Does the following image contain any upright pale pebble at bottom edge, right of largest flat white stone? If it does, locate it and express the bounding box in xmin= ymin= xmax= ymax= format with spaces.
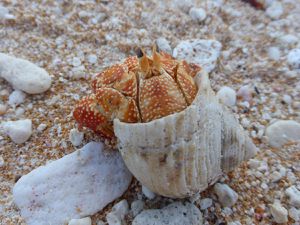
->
xmin=106 ymin=199 xmax=129 ymax=225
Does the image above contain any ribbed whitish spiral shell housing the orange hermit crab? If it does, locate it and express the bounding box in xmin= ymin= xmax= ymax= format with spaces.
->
xmin=114 ymin=71 xmax=256 ymax=198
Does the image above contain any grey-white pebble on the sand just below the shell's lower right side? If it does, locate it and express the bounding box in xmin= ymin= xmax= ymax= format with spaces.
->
xmin=214 ymin=183 xmax=238 ymax=207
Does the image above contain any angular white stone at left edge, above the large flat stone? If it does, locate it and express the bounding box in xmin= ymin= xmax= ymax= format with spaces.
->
xmin=1 ymin=119 xmax=32 ymax=144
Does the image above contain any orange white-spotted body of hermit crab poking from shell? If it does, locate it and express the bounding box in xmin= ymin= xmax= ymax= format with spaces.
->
xmin=73 ymin=47 xmax=201 ymax=139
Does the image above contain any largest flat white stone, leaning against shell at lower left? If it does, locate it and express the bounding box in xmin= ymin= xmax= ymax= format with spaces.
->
xmin=13 ymin=142 xmax=132 ymax=225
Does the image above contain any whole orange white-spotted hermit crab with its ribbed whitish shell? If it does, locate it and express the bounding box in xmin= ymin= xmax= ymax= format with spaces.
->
xmin=74 ymin=47 xmax=256 ymax=198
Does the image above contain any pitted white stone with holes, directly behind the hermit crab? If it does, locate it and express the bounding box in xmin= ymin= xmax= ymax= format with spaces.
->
xmin=173 ymin=39 xmax=222 ymax=73
